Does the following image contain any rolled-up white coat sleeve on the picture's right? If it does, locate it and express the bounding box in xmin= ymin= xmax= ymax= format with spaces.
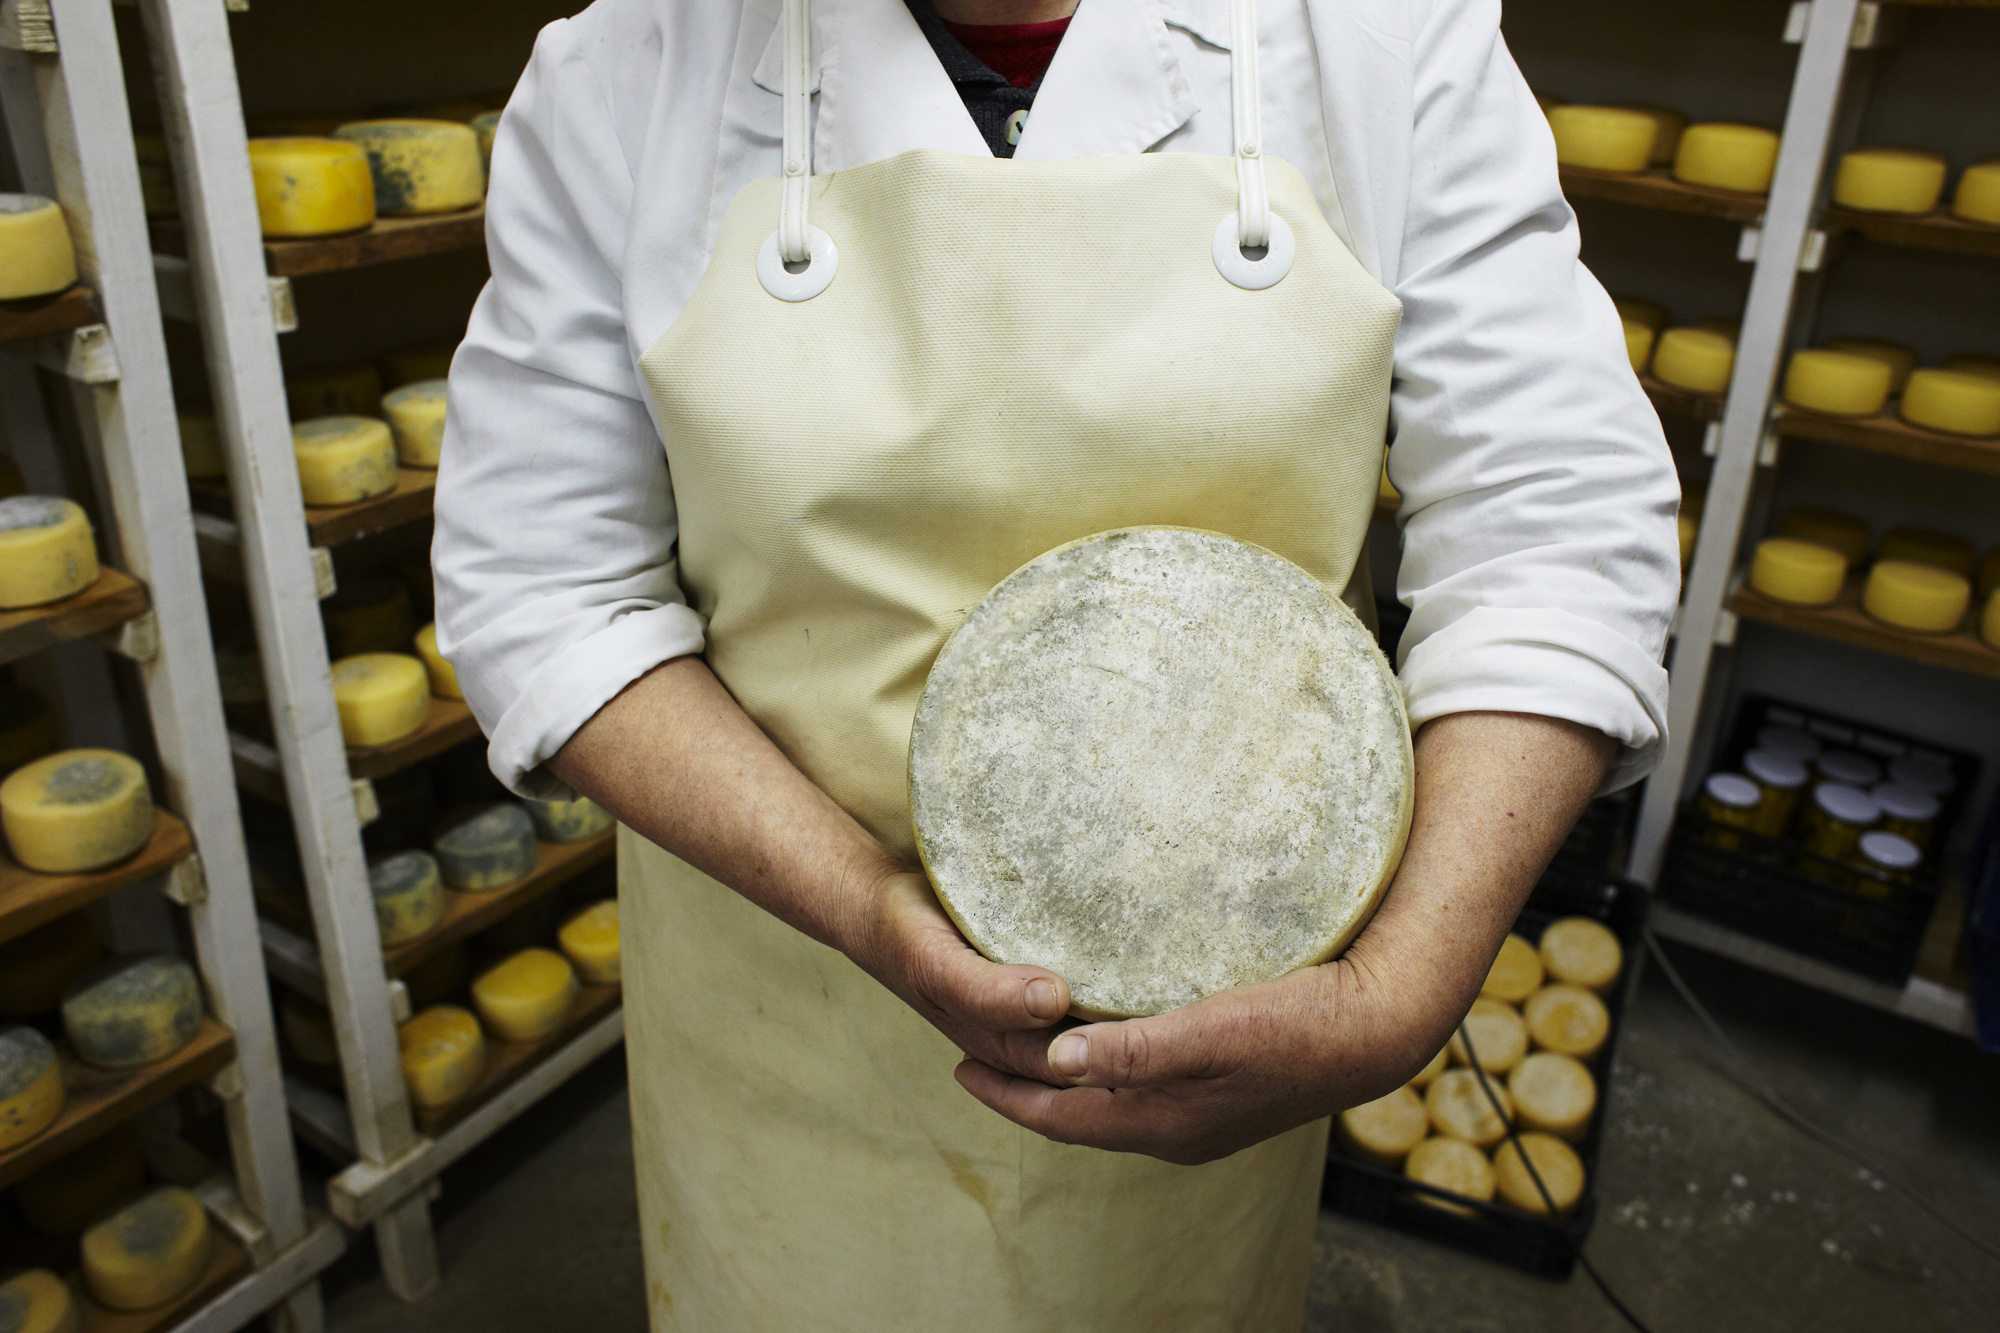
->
xmin=1388 ymin=0 xmax=1680 ymax=791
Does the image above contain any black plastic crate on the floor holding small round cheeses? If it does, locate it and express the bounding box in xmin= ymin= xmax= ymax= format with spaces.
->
xmin=1320 ymin=879 xmax=1646 ymax=1281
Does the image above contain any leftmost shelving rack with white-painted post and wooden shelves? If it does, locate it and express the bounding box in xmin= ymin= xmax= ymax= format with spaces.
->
xmin=0 ymin=0 xmax=346 ymax=1333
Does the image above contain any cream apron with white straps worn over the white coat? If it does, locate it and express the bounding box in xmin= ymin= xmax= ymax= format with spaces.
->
xmin=618 ymin=0 xmax=1398 ymax=1333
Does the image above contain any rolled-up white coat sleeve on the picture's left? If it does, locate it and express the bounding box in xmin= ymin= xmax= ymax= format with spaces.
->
xmin=432 ymin=22 xmax=702 ymax=799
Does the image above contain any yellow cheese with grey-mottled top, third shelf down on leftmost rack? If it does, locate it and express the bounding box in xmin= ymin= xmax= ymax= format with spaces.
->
xmin=0 ymin=751 xmax=152 ymax=875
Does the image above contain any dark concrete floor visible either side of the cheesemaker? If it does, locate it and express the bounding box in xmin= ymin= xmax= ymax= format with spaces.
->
xmin=312 ymin=951 xmax=2000 ymax=1333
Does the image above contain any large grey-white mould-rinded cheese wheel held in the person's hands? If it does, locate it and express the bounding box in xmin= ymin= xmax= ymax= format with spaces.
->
xmin=910 ymin=528 xmax=1412 ymax=1019
